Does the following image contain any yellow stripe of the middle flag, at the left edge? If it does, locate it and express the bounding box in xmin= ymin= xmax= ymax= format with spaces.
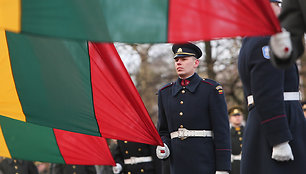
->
xmin=0 ymin=29 xmax=26 ymax=121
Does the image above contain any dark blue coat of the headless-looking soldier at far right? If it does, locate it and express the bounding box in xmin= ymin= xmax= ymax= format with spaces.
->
xmin=238 ymin=37 xmax=306 ymax=174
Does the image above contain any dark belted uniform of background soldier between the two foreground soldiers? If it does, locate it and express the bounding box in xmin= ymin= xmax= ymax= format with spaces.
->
xmin=230 ymin=126 xmax=244 ymax=174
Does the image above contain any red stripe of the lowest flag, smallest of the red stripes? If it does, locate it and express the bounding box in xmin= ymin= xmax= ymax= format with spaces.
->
xmin=53 ymin=129 xmax=115 ymax=165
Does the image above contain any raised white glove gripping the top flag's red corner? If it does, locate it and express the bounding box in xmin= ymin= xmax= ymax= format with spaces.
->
xmin=270 ymin=28 xmax=292 ymax=59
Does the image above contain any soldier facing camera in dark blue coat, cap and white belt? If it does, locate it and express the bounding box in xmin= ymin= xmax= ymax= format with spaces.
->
xmin=156 ymin=43 xmax=231 ymax=174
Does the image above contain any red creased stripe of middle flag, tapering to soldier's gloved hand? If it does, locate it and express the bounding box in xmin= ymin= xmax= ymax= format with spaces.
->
xmin=88 ymin=42 xmax=163 ymax=145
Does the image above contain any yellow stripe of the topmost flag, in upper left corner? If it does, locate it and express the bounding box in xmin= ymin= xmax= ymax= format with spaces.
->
xmin=0 ymin=0 xmax=21 ymax=32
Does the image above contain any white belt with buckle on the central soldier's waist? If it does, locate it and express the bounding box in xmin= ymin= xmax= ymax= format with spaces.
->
xmin=170 ymin=128 xmax=213 ymax=139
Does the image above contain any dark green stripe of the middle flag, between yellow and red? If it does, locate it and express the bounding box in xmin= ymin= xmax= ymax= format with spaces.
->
xmin=7 ymin=32 xmax=100 ymax=136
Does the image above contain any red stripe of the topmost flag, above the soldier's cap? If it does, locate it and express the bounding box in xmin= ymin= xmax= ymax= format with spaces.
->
xmin=168 ymin=0 xmax=280 ymax=42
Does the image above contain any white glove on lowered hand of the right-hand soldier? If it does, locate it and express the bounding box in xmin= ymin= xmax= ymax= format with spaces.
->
xmin=272 ymin=141 xmax=294 ymax=161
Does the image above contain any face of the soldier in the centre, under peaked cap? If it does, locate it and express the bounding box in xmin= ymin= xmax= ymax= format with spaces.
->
xmin=175 ymin=56 xmax=199 ymax=79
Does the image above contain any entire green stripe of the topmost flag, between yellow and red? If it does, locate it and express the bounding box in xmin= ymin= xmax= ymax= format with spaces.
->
xmin=21 ymin=0 xmax=168 ymax=42
